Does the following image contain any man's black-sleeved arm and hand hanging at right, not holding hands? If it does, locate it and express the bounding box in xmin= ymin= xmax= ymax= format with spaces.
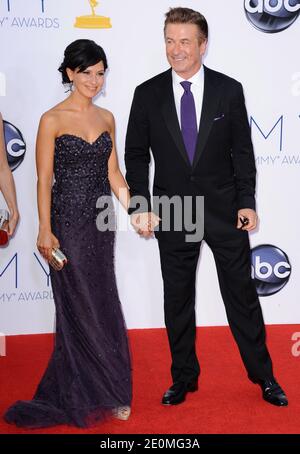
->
xmin=231 ymin=84 xmax=257 ymax=231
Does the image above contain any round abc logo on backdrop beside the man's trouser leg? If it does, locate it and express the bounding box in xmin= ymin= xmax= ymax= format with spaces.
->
xmin=251 ymin=244 xmax=291 ymax=296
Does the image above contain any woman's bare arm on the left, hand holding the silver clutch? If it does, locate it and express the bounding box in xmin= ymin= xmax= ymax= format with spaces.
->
xmin=36 ymin=113 xmax=59 ymax=261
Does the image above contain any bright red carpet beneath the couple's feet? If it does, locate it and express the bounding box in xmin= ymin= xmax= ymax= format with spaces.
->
xmin=0 ymin=325 xmax=300 ymax=434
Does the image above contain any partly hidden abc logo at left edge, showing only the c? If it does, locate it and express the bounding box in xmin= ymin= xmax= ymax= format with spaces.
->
xmin=3 ymin=121 xmax=26 ymax=171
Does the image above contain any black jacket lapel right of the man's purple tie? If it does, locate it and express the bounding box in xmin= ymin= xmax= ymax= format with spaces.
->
xmin=193 ymin=66 xmax=221 ymax=167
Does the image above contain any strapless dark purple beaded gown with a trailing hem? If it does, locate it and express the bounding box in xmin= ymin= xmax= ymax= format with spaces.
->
xmin=5 ymin=132 xmax=132 ymax=428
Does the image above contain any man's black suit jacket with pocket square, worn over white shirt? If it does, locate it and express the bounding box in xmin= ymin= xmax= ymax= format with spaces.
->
xmin=125 ymin=66 xmax=256 ymax=241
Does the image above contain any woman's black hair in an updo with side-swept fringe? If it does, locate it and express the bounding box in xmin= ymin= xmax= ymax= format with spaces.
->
xmin=58 ymin=39 xmax=107 ymax=84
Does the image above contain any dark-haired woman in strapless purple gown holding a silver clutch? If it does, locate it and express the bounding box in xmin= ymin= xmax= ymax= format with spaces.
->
xmin=5 ymin=39 xmax=132 ymax=428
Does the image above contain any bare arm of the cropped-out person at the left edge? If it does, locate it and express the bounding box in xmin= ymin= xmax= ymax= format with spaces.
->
xmin=0 ymin=114 xmax=19 ymax=236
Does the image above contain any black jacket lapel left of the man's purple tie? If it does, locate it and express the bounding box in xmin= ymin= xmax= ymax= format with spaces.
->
xmin=159 ymin=69 xmax=191 ymax=167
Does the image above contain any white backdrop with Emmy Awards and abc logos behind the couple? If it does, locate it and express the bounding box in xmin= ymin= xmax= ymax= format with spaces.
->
xmin=0 ymin=0 xmax=300 ymax=334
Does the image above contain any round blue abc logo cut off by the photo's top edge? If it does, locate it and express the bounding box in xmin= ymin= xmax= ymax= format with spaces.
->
xmin=244 ymin=0 xmax=300 ymax=33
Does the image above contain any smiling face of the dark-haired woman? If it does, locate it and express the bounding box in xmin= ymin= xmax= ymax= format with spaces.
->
xmin=67 ymin=61 xmax=105 ymax=98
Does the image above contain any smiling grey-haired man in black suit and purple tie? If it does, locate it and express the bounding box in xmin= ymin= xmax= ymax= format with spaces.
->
xmin=125 ymin=8 xmax=288 ymax=406
